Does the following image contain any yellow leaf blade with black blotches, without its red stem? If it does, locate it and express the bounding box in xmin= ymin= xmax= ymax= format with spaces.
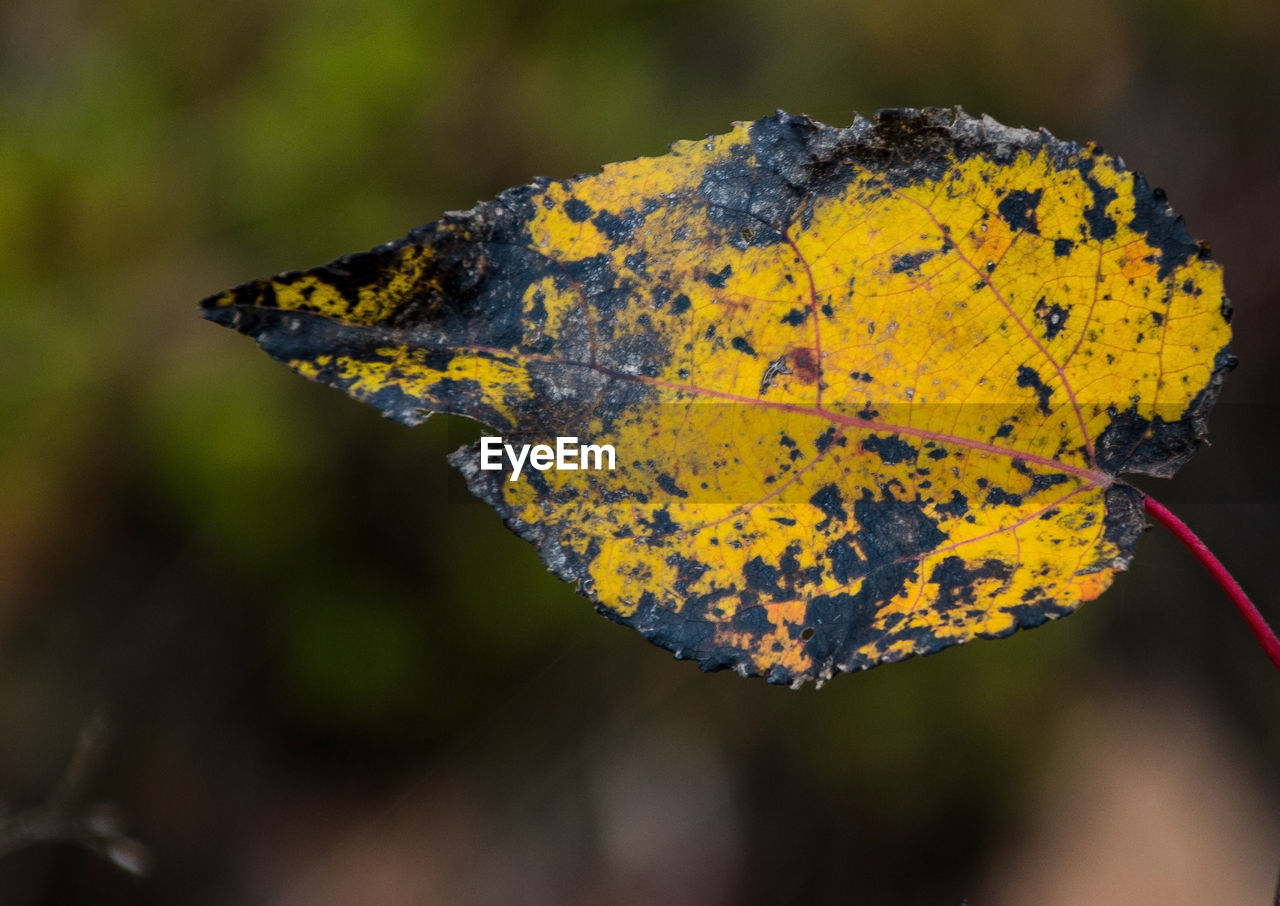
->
xmin=204 ymin=109 xmax=1234 ymax=685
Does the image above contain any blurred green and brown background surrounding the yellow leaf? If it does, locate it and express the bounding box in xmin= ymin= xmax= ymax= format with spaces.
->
xmin=0 ymin=0 xmax=1280 ymax=906
